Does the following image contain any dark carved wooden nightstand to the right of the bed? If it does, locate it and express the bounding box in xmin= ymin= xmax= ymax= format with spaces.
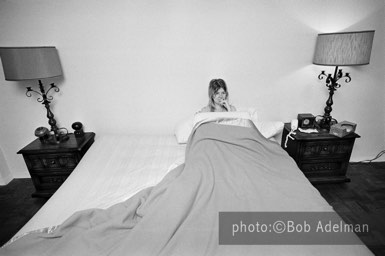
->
xmin=281 ymin=123 xmax=360 ymax=183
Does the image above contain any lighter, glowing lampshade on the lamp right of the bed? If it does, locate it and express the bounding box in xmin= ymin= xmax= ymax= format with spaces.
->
xmin=313 ymin=30 xmax=374 ymax=66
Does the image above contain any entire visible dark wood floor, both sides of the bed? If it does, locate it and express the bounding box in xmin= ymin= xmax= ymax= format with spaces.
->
xmin=0 ymin=162 xmax=385 ymax=255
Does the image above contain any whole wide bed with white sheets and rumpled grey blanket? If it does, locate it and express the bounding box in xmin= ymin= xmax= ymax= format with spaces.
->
xmin=0 ymin=112 xmax=372 ymax=255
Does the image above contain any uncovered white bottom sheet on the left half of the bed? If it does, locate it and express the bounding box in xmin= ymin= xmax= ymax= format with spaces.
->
xmin=15 ymin=135 xmax=186 ymax=236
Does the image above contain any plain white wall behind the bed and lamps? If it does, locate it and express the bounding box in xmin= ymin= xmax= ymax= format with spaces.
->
xmin=0 ymin=0 xmax=385 ymax=180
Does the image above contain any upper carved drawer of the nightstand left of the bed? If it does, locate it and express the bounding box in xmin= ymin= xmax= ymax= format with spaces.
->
xmin=24 ymin=153 xmax=79 ymax=170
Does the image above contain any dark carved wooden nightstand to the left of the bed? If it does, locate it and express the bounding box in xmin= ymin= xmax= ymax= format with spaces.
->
xmin=17 ymin=132 xmax=95 ymax=197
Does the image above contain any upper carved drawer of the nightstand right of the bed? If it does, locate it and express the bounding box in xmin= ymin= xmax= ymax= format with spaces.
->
xmin=300 ymin=140 xmax=354 ymax=159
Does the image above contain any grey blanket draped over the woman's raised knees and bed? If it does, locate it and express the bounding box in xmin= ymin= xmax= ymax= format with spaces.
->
xmin=0 ymin=123 xmax=370 ymax=256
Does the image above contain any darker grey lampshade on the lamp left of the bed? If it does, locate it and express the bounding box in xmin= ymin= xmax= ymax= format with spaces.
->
xmin=0 ymin=46 xmax=62 ymax=81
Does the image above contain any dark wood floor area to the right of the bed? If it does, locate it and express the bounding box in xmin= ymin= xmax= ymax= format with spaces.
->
xmin=315 ymin=162 xmax=385 ymax=255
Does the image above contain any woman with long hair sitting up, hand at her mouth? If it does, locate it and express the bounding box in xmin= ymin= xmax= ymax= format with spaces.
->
xmin=199 ymin=79 xmax=236 ymax=112
